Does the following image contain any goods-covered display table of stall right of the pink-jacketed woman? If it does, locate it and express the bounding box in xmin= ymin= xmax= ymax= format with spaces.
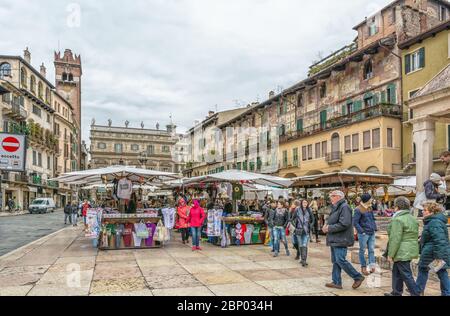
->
xmin=214 ymin=216 xmax=267 ymax=247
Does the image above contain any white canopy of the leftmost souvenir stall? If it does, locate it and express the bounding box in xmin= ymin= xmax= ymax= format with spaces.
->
xmin=53 ymin=166 xmax=179 ymax=185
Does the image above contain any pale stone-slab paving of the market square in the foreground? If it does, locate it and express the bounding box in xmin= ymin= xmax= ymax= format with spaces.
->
xmin=0 ymin=227 xmax=440 ymax=296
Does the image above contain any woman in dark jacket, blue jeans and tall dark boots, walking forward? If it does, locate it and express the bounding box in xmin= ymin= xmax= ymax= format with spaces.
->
xmin=291 ymin=200 xmax=314 ymax=267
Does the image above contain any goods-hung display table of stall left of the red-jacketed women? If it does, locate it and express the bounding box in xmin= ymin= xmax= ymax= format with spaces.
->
xmin=98 ymin=214 xmax=164 ymax=250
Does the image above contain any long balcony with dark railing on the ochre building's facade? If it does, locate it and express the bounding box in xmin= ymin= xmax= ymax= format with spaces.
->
xmin=280 ymin=104 xmax=402 ymax=143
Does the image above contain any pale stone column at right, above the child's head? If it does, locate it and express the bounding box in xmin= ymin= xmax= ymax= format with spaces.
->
xmin=413 ymin=118 xmax=436 ymax=192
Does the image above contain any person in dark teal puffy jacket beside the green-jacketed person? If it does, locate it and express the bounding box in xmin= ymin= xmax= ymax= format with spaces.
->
xmin=416 ymin=202 xmax=450 ymax=296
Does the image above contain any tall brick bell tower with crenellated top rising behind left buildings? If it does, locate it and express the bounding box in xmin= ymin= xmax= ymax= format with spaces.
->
xmin=54 ymin=49 xmax=83 ymax=130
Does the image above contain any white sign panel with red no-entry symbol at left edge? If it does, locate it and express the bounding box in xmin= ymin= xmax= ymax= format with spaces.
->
xmin=0 ymin=133 xmax=27 ymax=171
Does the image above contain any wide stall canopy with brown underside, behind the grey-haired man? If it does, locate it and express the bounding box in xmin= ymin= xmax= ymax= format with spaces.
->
xmin=291 ymin=171 xmax=394 ymax=188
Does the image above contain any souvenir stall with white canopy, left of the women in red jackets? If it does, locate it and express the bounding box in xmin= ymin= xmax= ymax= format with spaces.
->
xmin=55 ymin=166 xmax=177 ymax=250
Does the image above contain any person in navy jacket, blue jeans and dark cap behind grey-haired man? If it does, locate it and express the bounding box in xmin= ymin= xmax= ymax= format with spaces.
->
xmin=353 ymin=193 xmax=377 ymax=276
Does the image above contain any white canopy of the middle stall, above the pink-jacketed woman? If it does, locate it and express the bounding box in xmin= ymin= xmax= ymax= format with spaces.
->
xmin=183 ymin=170 xmax=292 ymax=187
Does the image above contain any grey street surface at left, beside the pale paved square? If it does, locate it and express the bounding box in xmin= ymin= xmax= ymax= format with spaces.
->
xmin=0 ymin=209 xmax=64 ymax=256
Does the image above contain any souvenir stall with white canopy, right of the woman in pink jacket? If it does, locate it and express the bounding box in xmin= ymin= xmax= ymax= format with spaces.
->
xmin=183 ymin=170 xmax=292 ymax=247
